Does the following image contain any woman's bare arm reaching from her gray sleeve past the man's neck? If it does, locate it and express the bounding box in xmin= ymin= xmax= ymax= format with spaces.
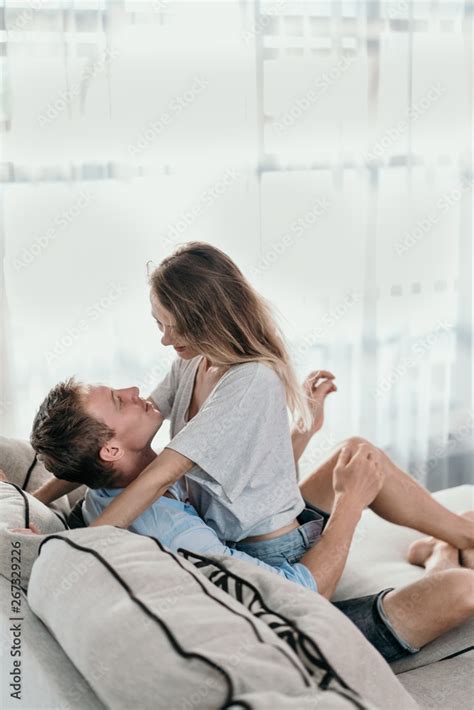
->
xmin=90 ymin=449 xmax=194 ymax=528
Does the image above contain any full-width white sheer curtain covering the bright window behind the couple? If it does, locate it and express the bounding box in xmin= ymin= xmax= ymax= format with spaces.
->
xmin=0 ymin=0 xmax=473 ymax=488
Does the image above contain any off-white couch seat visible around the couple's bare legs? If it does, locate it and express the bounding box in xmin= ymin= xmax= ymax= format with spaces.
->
xmin=333 ymin=485 xmax=474 ymax=673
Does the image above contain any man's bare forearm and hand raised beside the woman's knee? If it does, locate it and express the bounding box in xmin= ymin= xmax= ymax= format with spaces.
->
xmin=300 ymin=444 xmax=384 ymax=599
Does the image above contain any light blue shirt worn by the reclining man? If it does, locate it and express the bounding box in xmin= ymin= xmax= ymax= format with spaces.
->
xmin=82 ymin=488 xmax=317 ymax=591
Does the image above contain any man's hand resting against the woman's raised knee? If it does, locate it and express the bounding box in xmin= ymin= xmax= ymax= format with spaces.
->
xmin=333 ymin=444 xmax=385 ymax=510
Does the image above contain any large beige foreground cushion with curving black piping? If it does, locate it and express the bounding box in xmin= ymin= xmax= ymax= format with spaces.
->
xmin=28 ymin=526 xmax=416 ymax=710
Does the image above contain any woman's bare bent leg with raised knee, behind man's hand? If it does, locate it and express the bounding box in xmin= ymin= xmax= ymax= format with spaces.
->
xmin=301 ymin=437 xmax=474 ymax=550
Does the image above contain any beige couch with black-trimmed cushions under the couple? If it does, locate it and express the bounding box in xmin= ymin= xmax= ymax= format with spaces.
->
xmin=0 ymin=437 xmax=474 ymax=710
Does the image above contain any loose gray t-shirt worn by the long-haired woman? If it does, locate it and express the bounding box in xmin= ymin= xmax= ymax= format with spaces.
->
xmin=151 ymin=356 xmax=304 ymax=542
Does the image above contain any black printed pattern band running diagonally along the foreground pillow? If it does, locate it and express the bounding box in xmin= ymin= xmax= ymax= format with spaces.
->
xmin=178 ymin=549 xmax=364 ymax=708
